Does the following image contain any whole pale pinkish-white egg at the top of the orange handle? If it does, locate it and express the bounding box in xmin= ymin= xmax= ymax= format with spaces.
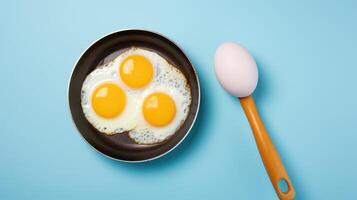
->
xmin=214 ymin=42 xmax=258 ymax=97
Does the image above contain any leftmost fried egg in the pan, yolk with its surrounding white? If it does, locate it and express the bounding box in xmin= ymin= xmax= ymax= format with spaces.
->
xmin=81 ymin=62 xmax=139 ymax=135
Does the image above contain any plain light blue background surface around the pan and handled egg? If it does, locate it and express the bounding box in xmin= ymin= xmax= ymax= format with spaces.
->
xmin=0 ymin=0 xmax=357 ymax=200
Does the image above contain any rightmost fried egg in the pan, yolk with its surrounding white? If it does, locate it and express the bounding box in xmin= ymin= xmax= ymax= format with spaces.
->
xmin=129 ymin=50 xmax=191 ymax=144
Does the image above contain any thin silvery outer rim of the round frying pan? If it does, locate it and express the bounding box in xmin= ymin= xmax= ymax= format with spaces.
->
xmin=67 ymin=28 xmax=201 ymax=163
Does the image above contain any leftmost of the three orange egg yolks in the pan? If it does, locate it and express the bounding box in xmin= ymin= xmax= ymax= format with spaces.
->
xmin=92 ymin=83 xmax=126 ymax=118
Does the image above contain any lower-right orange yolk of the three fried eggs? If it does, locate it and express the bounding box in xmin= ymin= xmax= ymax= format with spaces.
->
xmin=142 ymin=92 xmax=176 ymax=127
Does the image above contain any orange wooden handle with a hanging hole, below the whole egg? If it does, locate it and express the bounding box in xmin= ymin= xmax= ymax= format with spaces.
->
xmin=239 ymin=96 xmax=295 ymax=200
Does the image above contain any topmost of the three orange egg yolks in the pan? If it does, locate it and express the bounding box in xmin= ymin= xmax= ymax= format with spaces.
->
xmin=119 ymin=55 xmax=154 ymax=89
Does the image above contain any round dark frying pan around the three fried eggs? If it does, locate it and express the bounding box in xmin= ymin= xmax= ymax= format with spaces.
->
xmin=68 ymin=30 xmax=200 ymax=162
